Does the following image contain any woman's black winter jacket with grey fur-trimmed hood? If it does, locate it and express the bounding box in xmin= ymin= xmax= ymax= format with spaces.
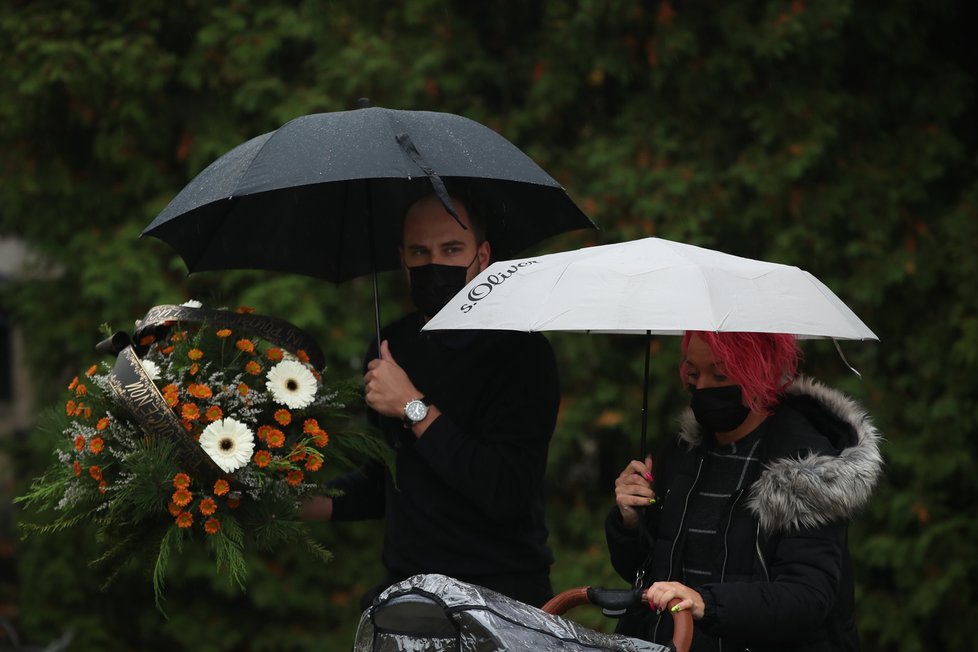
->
xmin=606 ymin=379 xmax=882 ymax=652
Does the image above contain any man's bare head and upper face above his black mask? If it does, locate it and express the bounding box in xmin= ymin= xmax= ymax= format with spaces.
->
xmin=401 ymin=195 xmax=489 ymax=282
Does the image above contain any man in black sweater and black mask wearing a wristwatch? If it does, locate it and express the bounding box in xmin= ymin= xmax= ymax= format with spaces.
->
xmin=307 ymin=195 xmax=560 ymax=607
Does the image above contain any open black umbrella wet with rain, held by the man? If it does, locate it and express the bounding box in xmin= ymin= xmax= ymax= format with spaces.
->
xmin=143 ymin=102 xmax=594 ymax=344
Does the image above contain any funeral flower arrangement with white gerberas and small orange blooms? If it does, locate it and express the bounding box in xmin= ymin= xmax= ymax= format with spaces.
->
xmin=17 ymin=304 xmax=390 ymax=603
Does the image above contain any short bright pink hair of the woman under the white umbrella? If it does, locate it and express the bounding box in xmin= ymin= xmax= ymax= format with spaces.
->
xmin=679 ymin=331 xmax=801 ymax=414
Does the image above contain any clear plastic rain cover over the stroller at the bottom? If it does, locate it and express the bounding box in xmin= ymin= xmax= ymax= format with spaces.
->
xmin=353 ymin=575 xmax=669 ymax=652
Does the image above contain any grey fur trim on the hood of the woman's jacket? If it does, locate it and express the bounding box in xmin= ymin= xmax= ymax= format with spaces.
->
xmin=679 ymin=377 xmax=883 ymax=533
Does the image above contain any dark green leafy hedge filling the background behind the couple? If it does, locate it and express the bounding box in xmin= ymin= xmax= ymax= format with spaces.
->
xmin=0 ymin=0 xmax=978 ymax=652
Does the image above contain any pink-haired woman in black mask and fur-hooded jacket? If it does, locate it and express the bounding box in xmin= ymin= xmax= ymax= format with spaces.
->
xmin=606 ymin=332 xmax=882 ymax=652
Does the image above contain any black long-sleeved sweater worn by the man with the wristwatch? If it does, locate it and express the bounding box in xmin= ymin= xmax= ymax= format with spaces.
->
xmin=333 ymin=314 xmax=560 ymax=601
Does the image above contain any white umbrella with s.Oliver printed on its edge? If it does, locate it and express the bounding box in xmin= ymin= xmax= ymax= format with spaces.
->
xmin=424 ymin=238 xmax=879 ymax=452
